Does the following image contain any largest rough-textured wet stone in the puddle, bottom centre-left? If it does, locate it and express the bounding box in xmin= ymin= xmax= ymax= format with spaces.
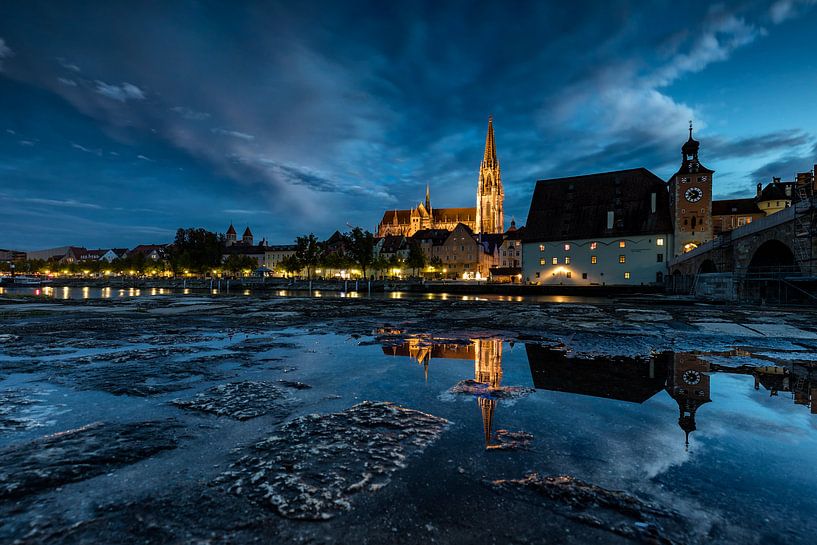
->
xmin=219 ymin=401 xmax=448 ymax=520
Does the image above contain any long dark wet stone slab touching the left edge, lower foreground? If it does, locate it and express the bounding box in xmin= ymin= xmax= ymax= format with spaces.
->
xmin=0 ymin=420 xmax=180 ymax=499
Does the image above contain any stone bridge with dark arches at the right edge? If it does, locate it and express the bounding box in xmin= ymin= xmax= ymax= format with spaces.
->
xmin=668 ymin=196 xmax=817 ymax=299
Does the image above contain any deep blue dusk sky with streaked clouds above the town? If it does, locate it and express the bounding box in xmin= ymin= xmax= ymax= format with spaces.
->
xmin=0 ymin=0 xmax=817 ymax=250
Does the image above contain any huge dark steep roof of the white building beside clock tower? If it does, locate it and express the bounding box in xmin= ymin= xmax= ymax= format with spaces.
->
xmin=523 ymin=168 xmax=672 ymax=242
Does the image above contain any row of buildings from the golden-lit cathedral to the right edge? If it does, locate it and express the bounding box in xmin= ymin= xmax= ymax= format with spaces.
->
xmin=377 ymin=119 xmax=817 ymax=285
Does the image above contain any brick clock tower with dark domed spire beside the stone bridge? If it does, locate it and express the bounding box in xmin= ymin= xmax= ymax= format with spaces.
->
xmin=669 ymin=121 xmax=715 ymax=255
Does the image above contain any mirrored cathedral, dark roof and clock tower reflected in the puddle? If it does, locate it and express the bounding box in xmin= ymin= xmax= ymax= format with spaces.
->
xmin=376 ymin=329 xmax=817 ymax=449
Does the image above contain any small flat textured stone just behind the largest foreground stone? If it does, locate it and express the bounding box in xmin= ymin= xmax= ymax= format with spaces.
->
xmin=171 ymin=380 xmax=289 ymax=420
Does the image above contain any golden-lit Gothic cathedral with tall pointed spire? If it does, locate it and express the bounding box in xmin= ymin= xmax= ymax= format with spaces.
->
xmin=377 ymin=117 xmax=505 ymax=237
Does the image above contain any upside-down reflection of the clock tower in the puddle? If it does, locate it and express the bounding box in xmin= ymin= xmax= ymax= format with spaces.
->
xmin=667 ymin=354 xmax=712 ymax=446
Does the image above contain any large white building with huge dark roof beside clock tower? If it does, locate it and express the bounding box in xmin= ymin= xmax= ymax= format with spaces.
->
xmin=522 ymin=168 xmax=673 ymax=286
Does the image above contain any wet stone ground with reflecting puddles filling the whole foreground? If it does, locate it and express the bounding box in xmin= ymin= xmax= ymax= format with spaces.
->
xmin=0 ymin=295 xmax=817 ymax=544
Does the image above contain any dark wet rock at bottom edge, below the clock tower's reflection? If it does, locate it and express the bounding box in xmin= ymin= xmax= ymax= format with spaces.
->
xmin=492 ymin=473 xmax=689 ymax=544
